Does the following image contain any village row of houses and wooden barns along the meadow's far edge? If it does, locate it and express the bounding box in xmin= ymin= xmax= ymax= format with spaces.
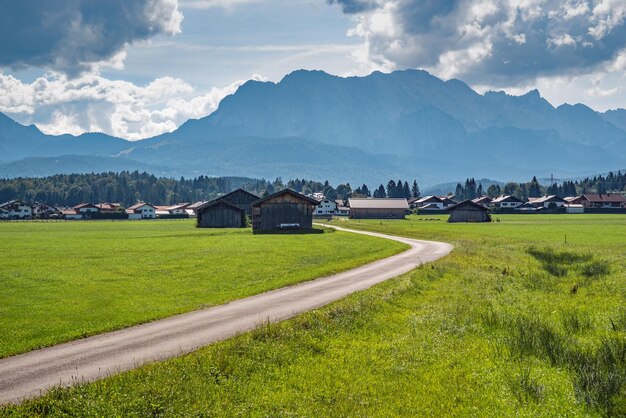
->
xmin=0 ymin=188 xmax=626 ymax=232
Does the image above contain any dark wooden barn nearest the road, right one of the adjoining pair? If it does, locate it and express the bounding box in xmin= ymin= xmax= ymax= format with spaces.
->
xmin=252 ymin=189 xmax=319 ymax=234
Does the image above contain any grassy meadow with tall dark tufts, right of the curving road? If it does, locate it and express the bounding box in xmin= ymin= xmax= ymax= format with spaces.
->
xmin=0 ymin=215 xmax=626 ymax=417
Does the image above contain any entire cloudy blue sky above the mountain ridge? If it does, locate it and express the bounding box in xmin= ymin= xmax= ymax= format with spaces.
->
xmin=0 ymin=0 xmax=626 ymax=140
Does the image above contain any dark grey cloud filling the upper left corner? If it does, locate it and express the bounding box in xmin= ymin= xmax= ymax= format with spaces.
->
xmin=0 ymin=0 xmax=183 ymax=75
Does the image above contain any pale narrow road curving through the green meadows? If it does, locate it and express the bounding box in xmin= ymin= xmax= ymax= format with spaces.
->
xmin=0 ymin=226 xmax=452 ymax=404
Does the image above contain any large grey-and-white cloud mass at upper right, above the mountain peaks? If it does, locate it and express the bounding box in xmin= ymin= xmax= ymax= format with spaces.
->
xmin=327 ymin=0 xmax=626 ymax=85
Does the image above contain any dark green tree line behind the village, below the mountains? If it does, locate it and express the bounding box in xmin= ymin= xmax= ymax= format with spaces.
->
xmin=0 ymin=171 xmax=626 ymax=206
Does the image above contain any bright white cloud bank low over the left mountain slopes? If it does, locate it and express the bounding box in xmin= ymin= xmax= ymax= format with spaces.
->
xmin=0 ymin=73 xmax=262 ymax=140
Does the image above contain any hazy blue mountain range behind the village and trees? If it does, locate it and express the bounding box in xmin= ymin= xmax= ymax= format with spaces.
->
xmin=0 ymin=70 xmax=626 ymax=185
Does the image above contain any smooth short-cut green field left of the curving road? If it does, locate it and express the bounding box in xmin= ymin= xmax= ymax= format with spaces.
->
xmin=0 ymin=221 xmax=405 ymax=357
